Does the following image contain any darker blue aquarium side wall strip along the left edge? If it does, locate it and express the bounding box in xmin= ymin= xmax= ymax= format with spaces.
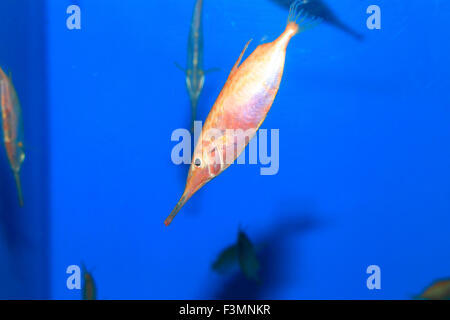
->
xmin=0 ymin=0 xmax=50 ymax=299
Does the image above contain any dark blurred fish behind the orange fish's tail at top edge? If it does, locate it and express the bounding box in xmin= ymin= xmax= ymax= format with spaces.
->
xmin=272 ymin=0 xmax=364 ymax=41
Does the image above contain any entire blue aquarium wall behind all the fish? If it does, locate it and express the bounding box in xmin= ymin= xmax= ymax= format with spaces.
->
xmin=0 ymin=0 xmax=450 ymax=299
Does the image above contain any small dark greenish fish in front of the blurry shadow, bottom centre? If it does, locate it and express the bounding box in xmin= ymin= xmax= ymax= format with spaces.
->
xmin=212 ymin=230 xmax=260 ymax=283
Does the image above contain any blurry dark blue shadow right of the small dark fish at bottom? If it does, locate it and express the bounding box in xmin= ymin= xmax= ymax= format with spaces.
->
xmin=212 ymin=206 xmax=321 ymax=300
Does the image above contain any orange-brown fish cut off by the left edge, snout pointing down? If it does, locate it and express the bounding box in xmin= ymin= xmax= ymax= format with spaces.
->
xmin=0 ymin=68 xmax=25 ymax=206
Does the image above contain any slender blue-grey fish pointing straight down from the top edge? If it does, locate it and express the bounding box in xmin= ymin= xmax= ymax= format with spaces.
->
xmin=176 ymin=0 xmax=216 ymax=132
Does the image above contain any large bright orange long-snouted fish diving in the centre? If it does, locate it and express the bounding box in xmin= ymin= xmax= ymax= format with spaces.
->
xmin=164 ymin=0 xmax=318 ymax=226
